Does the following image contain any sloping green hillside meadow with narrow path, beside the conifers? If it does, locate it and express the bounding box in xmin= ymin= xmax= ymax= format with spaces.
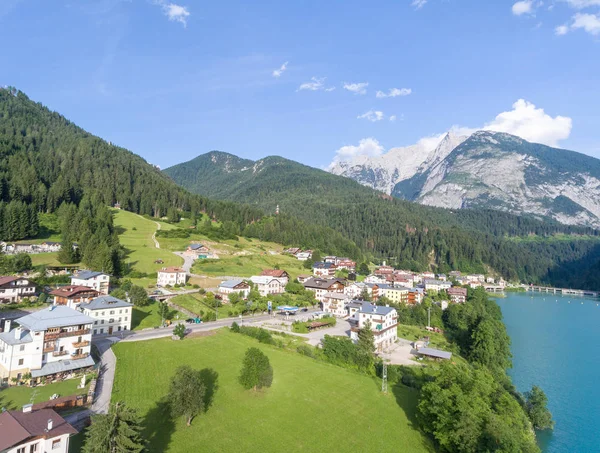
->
xmin=114 ymin=210 xmax=183 ymax=276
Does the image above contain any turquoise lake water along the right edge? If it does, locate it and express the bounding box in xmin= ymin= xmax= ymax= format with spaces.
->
xmin=497 ymin=293 xmax=600 ymax=453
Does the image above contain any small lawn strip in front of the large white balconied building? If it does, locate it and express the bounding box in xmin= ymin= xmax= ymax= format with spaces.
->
xmin=0 ymin=378 xmax=87 ymax=410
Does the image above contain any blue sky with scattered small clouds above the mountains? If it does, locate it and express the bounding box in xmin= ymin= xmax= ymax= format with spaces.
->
xmin=0 ymin=0 xmax=600 ymax=168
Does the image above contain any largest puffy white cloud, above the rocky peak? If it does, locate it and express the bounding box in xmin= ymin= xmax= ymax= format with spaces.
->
xmin=483 ymin=99 xmax=573 ymax=146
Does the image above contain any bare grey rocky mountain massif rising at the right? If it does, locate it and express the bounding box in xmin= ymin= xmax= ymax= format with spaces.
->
xmin=336 ymin=131 xmax=600 ymax=228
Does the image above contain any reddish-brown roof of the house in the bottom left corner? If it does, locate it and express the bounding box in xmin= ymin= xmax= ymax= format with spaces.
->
xmin=0 ymin=409 xmax=77 ymax=451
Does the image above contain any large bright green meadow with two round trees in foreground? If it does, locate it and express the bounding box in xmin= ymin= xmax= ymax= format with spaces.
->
xmin=112 ymin=331 xmax=434 ymax=453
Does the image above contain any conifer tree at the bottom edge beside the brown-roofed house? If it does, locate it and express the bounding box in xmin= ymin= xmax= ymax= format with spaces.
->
xmin=82 ymin=402 xmax=144 ymax=453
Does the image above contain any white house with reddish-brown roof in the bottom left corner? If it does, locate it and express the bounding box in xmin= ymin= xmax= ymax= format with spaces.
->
xmin=0 ymin=404 xmax=77 ymax=453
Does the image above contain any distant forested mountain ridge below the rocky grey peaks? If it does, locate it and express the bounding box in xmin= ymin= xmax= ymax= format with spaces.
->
xmin=165 ymin=152 xmax=598 ymax=288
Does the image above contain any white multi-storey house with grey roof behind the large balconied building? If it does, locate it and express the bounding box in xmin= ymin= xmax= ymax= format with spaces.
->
xmin=79 ymin=296 xmax=133 ymax=335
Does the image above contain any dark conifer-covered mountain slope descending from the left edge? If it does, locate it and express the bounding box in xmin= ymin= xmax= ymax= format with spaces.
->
xmin=0 ymin=88 xmax=361 ymax=266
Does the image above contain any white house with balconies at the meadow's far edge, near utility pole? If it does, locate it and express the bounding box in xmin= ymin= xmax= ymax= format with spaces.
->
xmin=350 ymin=302 xmax=398 ymax=352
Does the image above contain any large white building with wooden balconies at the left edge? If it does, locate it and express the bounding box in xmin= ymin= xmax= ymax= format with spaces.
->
xmin=0 ymin=305 xmax=94 ymax=384
